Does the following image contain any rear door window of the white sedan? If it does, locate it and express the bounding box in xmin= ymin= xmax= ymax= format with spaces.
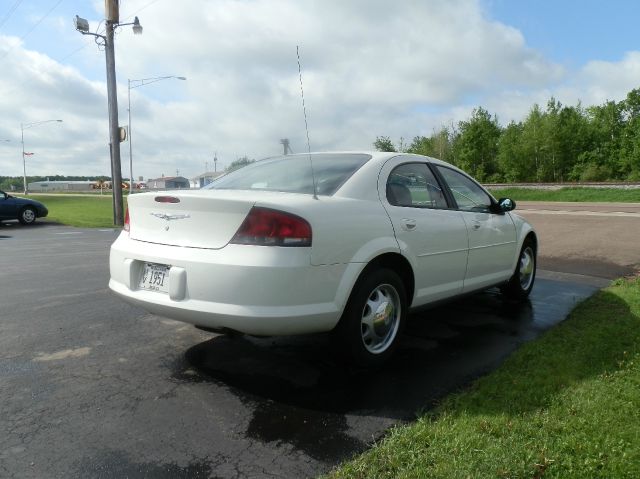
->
xmin=387 ymin=163 xmax=447 ymax=208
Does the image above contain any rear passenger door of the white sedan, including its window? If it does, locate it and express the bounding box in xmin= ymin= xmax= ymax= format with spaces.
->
xmin=379 ymin=155 xmax=468 ymax=306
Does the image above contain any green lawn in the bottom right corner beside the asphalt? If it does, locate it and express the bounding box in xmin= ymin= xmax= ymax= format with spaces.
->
xmin=329 ymin=278 xmax=640 ymax=479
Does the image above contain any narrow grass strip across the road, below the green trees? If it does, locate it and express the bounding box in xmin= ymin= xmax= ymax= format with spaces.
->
xmin=491 ymin=187 xmax=640 ymax=203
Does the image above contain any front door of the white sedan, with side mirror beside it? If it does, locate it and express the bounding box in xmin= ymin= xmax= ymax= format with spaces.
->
xmin=436 ymin=165 xmax=517 ymax=292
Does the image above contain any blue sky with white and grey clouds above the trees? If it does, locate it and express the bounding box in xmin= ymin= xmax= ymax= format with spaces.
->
xmin=0 ymin=0 xmax=640 ymax=178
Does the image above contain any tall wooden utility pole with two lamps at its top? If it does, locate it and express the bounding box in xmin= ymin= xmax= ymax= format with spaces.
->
xmin=74 ymin=0 xmax=142 ymax=226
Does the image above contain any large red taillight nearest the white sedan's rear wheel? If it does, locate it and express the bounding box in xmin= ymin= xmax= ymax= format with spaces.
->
xmin=231 ymin=206 xmax=311 ymax=246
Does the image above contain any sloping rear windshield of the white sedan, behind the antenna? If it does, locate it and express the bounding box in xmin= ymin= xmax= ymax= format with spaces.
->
xmin=205 ymin=153 xmax=371 ymax=196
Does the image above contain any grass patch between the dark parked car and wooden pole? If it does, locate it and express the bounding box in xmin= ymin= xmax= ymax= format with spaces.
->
xmin=29 ymin=194 xmax=126 ymax=228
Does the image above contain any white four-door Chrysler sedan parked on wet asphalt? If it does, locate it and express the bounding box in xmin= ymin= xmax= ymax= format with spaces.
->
xmin=109 ymin=152 xmax=538 ymax=365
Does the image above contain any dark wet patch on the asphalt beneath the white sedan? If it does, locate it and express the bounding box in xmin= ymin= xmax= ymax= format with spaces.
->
xmin=172 ymin=280 xmax=595 ymax=463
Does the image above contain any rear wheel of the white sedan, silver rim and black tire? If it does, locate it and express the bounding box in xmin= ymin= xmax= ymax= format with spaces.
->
xmin=334 ymin=269 xmax=407 ymax=368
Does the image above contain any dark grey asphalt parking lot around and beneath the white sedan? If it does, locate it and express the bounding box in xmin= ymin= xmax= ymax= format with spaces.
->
xmin=0 ymin=207 xmax=640 ymax=478
